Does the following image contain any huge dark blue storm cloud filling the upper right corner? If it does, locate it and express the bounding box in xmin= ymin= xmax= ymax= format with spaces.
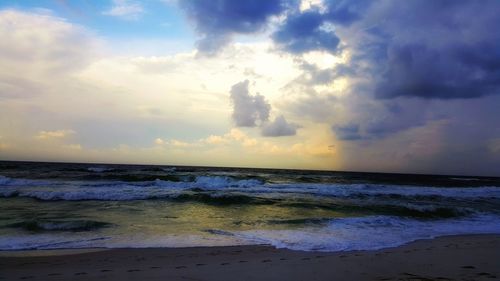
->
xmin=354 ymin=0 xmax=500 ymax=99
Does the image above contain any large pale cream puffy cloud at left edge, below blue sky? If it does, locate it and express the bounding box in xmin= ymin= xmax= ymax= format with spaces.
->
xmin=0 ymin=9 xmax=99 ymax=99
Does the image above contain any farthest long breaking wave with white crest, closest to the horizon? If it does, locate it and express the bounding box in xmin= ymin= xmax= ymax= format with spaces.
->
xmin=0 ymin=173 xmax=500 ymax=201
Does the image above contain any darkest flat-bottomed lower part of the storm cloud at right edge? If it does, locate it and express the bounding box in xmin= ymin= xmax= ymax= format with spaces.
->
xmin=375 ymin=41 xmax=500 ymax=99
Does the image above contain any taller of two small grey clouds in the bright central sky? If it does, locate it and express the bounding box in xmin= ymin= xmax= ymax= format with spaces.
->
xmin=230 ymin=80 xmax=271 ymax=127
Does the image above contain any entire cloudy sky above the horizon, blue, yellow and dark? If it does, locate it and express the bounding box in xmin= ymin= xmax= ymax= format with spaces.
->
xmin=0 ymin=0 xmax=500 ymax=176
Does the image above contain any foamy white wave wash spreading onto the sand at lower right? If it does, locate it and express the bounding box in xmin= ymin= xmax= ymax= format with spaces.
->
xmin=232 ymin=215 xmax=500 ymax=251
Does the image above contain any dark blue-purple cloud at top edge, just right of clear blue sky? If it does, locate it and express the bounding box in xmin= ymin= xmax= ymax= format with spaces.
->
xmin=179 ymin=0 xmax=288 ymax=55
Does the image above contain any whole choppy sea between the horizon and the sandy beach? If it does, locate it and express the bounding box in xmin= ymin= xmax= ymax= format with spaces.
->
xmin=0 ymin=161 xmax=500 ymax=251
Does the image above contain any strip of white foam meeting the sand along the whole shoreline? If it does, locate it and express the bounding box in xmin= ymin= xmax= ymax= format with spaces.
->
xmin=0 ymin=215 xmax=500 ymax=251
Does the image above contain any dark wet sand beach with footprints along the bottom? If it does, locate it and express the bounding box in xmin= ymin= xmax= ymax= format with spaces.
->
xmin=0 ymin=235 xmax=500 ymax=281
